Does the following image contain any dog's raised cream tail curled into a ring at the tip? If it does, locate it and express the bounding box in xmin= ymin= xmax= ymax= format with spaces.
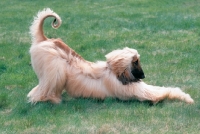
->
xmin=30 ymin=8 xmax=62 ymax=44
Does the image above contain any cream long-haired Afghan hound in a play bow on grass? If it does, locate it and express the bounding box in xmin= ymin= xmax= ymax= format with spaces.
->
xmin=27 ymin=8 xmax=194 ymax=104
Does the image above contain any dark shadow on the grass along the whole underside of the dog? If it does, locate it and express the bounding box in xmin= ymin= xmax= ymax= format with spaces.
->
xmin=13 ymin=93 xmax=164 ymax=116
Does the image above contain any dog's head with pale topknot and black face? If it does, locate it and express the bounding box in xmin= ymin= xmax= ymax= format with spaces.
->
xmin=106 ymin=47 xmax=145 ymax=85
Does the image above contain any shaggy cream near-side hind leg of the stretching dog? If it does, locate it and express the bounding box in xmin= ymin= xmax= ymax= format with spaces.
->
xmin=27 ymin=58 xmax=66 ymax=103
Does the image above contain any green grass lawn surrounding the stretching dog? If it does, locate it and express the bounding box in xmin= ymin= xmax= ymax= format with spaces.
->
xmin=0 ymin=0 xmax=200 ymax=134
